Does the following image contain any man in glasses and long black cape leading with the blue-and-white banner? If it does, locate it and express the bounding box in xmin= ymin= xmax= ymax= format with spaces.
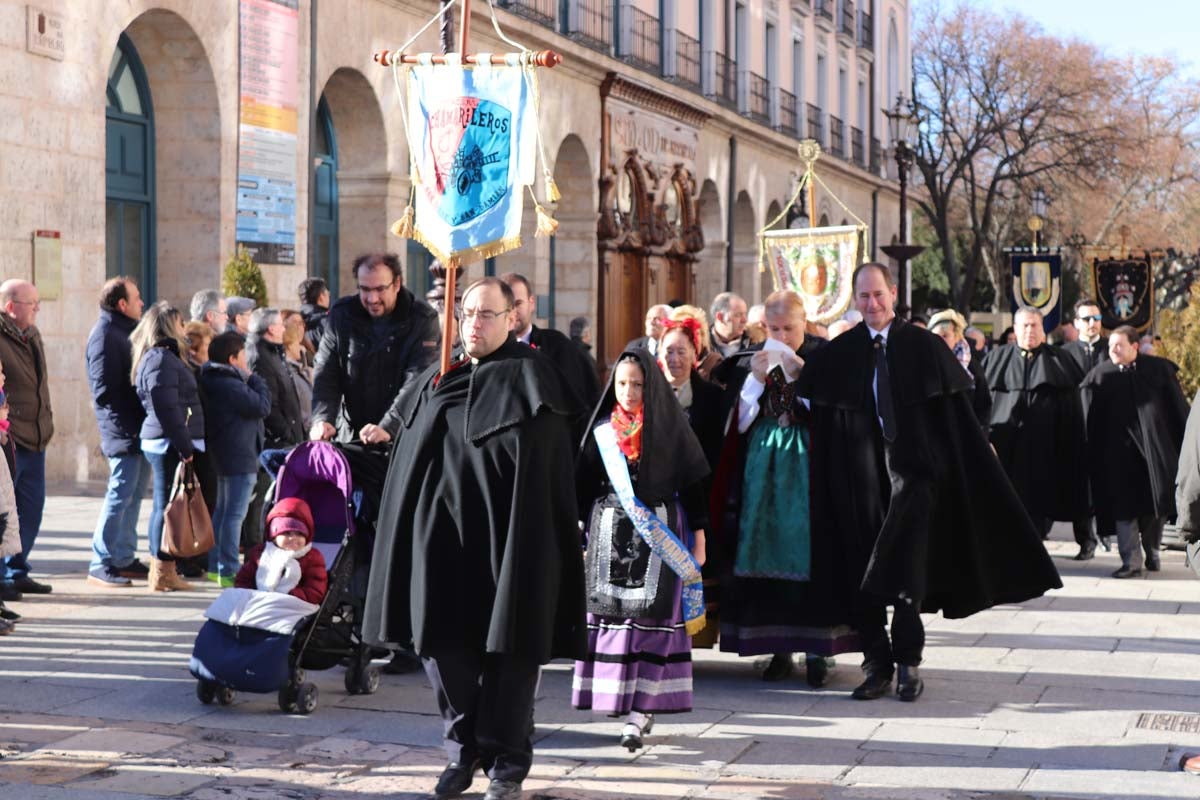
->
xmin=362 ymin=278 xmax=586 ymax=800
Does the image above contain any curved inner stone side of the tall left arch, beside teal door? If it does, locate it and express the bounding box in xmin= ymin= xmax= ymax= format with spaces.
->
xmin=125 ymin=8 xmax=224 ymax=308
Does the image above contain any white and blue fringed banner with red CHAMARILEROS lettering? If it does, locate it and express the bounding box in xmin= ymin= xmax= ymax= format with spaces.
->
xmin=408 ymin=64 xmax=536 ymax=264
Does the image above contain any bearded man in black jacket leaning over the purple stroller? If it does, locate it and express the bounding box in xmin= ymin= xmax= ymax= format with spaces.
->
xmin=308 ymin=253 xmax=439 ymax=444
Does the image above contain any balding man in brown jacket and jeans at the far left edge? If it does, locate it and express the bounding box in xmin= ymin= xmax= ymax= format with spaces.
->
xmin=0 ymin=278 xmax=54 ymax=600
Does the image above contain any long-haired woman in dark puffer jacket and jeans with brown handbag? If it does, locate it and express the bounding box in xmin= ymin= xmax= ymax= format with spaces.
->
xmin=130 ymin=301 xmax=204 ymax=591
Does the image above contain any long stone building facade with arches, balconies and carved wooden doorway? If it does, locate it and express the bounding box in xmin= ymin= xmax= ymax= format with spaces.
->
xmin=0 ymin=0 xmax=911 ymax=482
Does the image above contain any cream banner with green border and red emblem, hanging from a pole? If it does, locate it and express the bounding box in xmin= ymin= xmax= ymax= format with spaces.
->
xmin=760 ymin=225 xmax=866 ymax=325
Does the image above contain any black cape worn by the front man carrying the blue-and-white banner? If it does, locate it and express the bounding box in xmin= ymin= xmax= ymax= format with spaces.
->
xmin=362 ymin=337 xmax=586 ymax=663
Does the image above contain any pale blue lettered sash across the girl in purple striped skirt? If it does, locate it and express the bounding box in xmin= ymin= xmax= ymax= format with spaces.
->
xmin=592 ymin=422 xmax=704 ymax=636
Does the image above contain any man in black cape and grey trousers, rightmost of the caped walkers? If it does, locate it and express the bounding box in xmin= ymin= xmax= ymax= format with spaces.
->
xmin=1082 ymin=325 xmax=1188 ymax=578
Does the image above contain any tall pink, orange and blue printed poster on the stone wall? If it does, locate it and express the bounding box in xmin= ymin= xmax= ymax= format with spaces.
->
xmin=238 ymin=0 xmax=300 ymax=264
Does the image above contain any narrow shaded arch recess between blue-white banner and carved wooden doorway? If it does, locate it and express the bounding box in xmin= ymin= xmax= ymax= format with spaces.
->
xmin=549 ymin=133 xmax=598 ymax=331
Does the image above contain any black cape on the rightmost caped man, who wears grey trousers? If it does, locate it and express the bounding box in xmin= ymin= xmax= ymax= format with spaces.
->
xmin=1081 ymin=355 xmax=1188 ymax=519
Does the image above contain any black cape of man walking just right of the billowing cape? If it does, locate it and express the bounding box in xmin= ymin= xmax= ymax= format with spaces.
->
xmin=983 ymin=344 xmax=1090 ymax=521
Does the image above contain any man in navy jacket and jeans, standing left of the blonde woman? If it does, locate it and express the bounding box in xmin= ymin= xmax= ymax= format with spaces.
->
xmin=86 ymin=277 xmax=150 ymax=588
